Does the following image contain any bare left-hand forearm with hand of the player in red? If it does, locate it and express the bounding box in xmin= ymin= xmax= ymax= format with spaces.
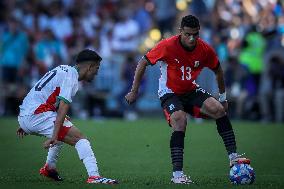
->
xmin=125 ymin=57 xmax=148 ymax=104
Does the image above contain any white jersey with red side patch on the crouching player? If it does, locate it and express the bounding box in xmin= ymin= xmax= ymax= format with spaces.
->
xmin=20 ymin=65 xmax=79 ymax=116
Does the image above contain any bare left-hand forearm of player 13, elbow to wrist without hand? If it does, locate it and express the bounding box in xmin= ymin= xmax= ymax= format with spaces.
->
xmin=131 ymin=58 xmax=148 ymax=93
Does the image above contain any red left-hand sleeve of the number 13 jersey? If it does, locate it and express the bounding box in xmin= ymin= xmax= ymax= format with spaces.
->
xmin=144 ymin=40 xmax=166 ymax=65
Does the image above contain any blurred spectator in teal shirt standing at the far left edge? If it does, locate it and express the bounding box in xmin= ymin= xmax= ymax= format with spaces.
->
xmin=0 ymin=17 xmax=29 ymax=114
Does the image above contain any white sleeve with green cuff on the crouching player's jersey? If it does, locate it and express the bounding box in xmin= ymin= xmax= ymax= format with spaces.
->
xmin=58 ymin=71 xmax=78 ymax=104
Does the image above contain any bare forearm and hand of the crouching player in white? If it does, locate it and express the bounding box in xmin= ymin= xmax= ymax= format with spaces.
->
xmin=43 ymin=100 xmax=69 ymax=149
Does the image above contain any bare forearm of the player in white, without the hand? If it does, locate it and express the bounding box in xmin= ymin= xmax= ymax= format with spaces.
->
xmin=53 ymin=101 xmax=69 ymax=139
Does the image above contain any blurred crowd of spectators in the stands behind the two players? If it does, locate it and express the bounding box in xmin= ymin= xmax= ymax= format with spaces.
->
xmin=0 ymin=0 xmax=284 ymax=123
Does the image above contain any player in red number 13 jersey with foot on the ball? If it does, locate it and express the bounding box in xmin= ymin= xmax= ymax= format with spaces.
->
xmin=125 ymin=15 xmax=250 ymax=184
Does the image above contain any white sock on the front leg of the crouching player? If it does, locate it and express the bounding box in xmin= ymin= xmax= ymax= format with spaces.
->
xmin=75 ymin=139 xmax=99 ymax=177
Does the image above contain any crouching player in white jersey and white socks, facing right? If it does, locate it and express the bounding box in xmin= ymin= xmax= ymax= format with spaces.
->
xmin=17 ymin=49 xmax=118 ymax=184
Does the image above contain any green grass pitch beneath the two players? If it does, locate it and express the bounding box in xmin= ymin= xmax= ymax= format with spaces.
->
xmin=0 ymin=118 xmax=284 ymax=189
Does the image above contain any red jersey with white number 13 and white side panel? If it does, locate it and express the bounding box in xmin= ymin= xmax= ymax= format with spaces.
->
xmin=145 ymin=35 xmax=219 ymax=97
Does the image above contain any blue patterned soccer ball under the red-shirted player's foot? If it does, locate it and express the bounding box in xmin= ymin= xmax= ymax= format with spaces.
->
xmin=230 ymin=164 xmax=255 ymax=184
